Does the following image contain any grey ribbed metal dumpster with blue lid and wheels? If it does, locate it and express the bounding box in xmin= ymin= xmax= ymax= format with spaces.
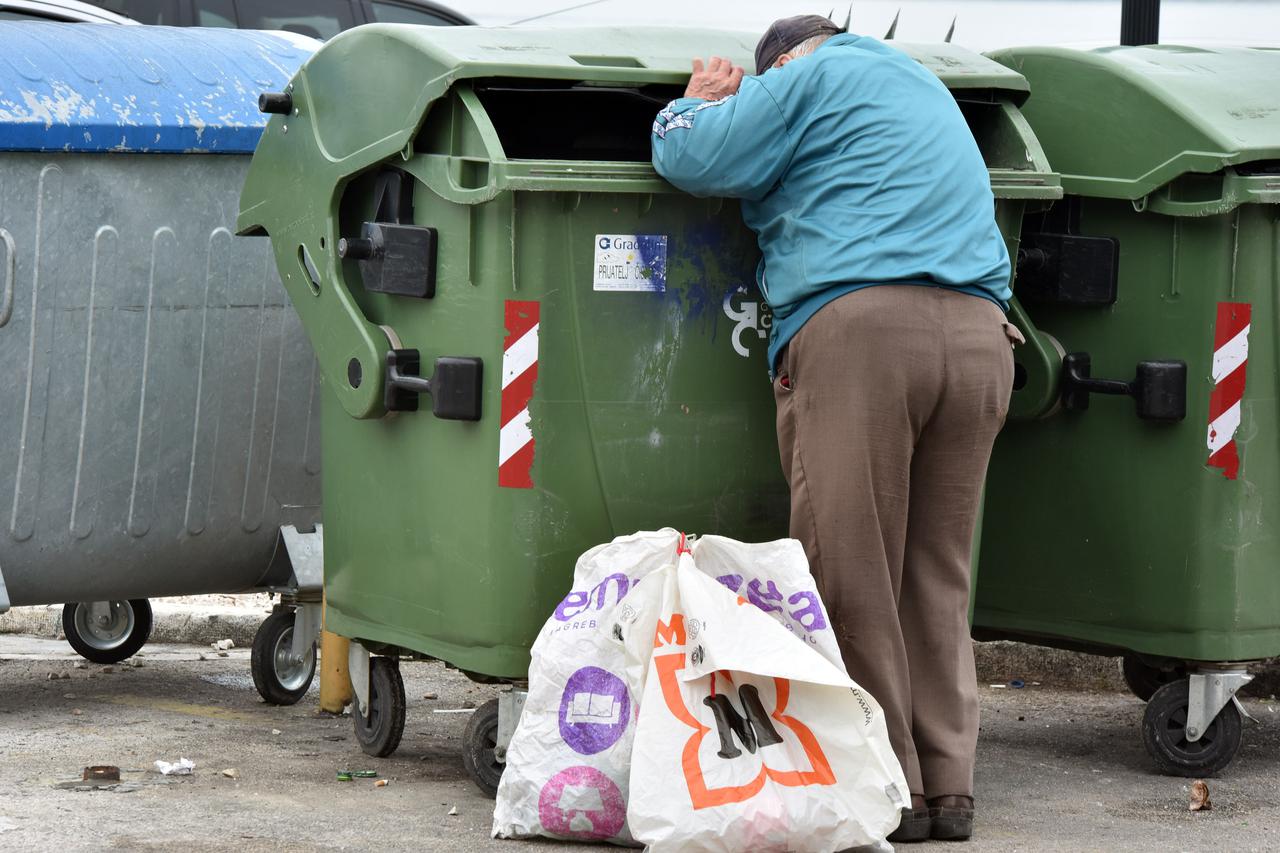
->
xmin=0 ymin=23 xmax=320 ymax=701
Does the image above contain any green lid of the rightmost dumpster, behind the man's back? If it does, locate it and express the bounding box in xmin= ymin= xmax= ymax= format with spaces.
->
xmin=991 ymin=45 xmax=1280 ymax=200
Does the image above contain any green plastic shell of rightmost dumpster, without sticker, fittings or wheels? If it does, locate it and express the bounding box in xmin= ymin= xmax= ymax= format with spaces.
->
xmin=974 ymin=47 xmax=1280 ymax=662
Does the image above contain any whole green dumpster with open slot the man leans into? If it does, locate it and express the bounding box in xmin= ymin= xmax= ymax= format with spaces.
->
xmin=238 ymin=26 xmax=1061 ymax=783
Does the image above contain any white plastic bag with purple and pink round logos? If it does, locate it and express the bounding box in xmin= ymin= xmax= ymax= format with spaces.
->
xmin=493 ymin=529 xmax=680 ymax=844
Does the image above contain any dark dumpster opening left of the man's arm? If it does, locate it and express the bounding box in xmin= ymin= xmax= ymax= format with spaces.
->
xmin=475 ymin=78 xmax=684 ymax=163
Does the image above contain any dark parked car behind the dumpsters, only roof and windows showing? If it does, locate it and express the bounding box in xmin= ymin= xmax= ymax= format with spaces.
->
xmin=80 ymin=0 xmax=475 ymax=38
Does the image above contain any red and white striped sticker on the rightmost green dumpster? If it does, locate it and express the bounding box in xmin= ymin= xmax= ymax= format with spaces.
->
xmin=1208 ymin=302 xmax=1253 ymax=480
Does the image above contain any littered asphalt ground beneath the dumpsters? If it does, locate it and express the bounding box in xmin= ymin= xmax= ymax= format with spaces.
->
xmin=0 ymin=635 xmax=1280 ymax=853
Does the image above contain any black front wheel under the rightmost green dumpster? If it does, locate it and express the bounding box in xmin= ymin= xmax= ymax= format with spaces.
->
xmin=1142 ymin=679 xmax=1242 ymax=777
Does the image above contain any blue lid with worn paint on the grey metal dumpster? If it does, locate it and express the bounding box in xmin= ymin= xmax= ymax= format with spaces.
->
xmin=0 ymin=22 xmax=320 ymax=154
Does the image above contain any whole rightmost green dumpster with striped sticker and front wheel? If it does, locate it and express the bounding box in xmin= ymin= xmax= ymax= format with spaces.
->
xmin=974 ymin=45 xmax=1280 ymax=775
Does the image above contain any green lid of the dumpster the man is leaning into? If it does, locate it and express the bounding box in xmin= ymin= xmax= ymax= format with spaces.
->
xmin=241 ymin=23 xmax=1028 ymax=197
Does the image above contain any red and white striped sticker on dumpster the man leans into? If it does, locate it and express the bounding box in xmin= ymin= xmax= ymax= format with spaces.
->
xmin=498 ymin=300 xmax=539 ymax=489
